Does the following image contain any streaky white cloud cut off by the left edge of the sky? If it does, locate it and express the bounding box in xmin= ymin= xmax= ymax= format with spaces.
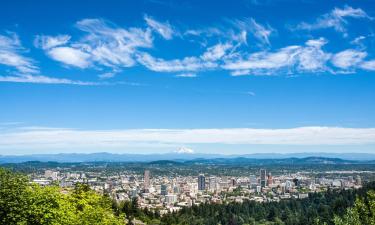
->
xmin=0 ymin=33 xmax=39 ymax=73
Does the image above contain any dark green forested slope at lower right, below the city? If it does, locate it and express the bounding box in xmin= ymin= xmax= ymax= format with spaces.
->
xmin=161 ymin=182 xmax=375 ymax=225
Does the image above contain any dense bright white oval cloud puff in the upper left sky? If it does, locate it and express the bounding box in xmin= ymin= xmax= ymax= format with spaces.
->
xmin=47 ymin=47 xmax=91 ymax=68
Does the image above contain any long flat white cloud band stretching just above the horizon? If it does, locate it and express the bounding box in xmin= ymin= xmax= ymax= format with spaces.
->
xmin=0 ymin=127 xmax=375 ymax=151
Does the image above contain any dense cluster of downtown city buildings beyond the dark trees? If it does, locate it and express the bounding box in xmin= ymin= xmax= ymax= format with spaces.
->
xmin=32 ymin=169 xmax=362 ymax=214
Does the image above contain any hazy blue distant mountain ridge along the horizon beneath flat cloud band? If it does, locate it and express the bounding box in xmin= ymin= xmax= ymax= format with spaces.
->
xmin=0 ymin=152 xmax=375 ymax=163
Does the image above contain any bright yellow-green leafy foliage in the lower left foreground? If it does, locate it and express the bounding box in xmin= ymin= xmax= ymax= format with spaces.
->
xmin=0 ymin=169 xmax=125 ymax=225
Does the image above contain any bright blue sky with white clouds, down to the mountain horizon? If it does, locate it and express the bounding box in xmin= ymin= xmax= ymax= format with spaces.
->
xmin=0 ymin=0 xmax=375 ymax=154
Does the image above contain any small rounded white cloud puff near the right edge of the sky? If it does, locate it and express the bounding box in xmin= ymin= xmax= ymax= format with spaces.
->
xmin=332 ymin=49 xmax=367 ymax=69
